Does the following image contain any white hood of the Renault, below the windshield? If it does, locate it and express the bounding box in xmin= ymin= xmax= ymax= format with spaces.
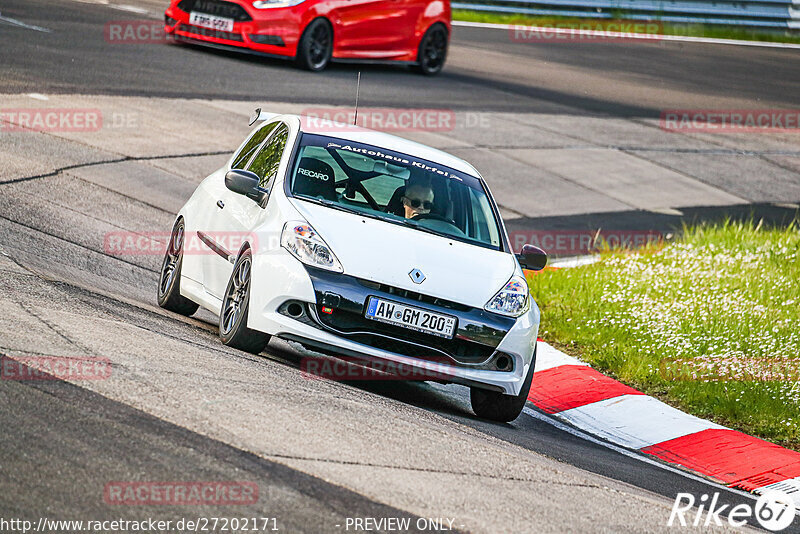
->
xmin=292 ymin=199 xmax=516 ymax=308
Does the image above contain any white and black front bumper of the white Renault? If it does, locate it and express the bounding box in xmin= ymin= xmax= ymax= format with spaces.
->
xmin=248 ymin=253 xmax=539 ymax=395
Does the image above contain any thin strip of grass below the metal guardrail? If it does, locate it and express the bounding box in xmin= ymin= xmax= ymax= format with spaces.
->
xmin=453 ymin=9 xmax=800 ymax=44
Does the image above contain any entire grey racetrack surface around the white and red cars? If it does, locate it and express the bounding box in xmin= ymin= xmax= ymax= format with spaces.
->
xmin=0 ymin=0 xmax=800 ymax=532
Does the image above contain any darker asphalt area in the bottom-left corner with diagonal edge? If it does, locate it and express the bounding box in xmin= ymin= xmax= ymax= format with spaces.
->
xmin=0 ymin=364 xmax=438 ymax=532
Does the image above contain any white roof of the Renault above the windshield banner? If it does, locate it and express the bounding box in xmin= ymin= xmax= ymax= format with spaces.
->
xmin=268 ymin=112 xmax=481 ymax=178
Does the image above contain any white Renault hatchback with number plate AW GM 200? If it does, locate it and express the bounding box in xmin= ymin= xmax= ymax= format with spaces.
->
xmin=158 ymin=110 xmax=547 ymax=421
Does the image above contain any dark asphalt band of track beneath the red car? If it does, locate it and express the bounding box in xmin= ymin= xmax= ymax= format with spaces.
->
xmin=0 ymin=0 xmax=800 ymax=113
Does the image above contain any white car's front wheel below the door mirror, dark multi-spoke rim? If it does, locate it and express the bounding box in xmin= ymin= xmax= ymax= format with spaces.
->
xmin=219 ymin=249 xmax=269 ymax=354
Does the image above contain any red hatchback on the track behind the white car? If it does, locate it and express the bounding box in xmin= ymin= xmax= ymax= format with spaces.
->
xmin=165 ymin=0 xmax=450 ymax=74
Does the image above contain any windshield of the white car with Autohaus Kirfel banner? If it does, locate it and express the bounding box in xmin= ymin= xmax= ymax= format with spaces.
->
xmin=289 ymin=134 xmax=501 ymax=250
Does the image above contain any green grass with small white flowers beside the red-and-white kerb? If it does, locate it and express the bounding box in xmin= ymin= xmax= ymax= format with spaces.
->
xmin=529 ymin=222 xmax=800 ymax=450
